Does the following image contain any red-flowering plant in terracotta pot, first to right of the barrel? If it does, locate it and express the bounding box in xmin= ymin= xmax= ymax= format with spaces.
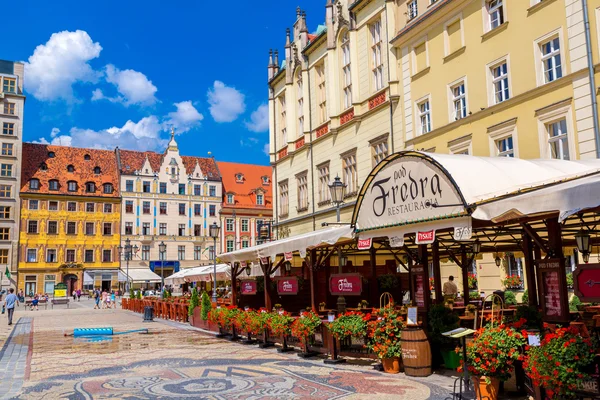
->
xmin=467 ymin=323 xmax=526 ymax=400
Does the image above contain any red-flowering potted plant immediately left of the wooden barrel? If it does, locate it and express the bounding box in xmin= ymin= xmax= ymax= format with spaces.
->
xmin=367 ymin=304 xmax=405 ymax=374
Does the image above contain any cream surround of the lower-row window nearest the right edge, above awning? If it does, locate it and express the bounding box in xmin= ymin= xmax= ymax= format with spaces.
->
xmin=536 ymin=101 xmax=577 ymax=160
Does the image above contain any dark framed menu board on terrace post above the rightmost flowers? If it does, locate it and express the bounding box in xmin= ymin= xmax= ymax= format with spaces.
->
xmin=538 ymin=258 xmax=569 ymax=322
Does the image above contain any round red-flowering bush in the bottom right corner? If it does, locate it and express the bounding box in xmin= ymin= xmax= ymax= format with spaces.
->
xmin=523 ymin=327 xmax=595 ymax=399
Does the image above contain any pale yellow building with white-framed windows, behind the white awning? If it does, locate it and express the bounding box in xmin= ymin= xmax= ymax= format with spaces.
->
xmin=390 ymin=0 xmax=600 ymax=293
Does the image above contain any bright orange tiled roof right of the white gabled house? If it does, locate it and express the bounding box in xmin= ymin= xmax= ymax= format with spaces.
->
xmin=218 ymin=161 xmax=273 ymax=210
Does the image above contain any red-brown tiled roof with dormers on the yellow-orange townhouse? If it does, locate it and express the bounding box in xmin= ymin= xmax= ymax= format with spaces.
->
xmin=21 ymin=143 xmax=119 ymax=197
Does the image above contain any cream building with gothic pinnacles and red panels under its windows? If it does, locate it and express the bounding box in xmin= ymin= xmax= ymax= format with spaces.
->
xmin=268 ymin=0 xmax=403 ymax=238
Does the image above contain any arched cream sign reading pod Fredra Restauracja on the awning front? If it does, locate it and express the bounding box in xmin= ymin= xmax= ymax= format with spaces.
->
xmin=355 ymin=155 xmax=465 ymax=231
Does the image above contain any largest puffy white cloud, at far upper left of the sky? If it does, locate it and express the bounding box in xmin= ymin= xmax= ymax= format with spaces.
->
xmin=25 ymin=30 xmax=102 ymax=102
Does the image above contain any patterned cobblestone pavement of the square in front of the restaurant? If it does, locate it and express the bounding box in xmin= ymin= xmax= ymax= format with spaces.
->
xmin=0 ymin=304 xmax=460 ymax=400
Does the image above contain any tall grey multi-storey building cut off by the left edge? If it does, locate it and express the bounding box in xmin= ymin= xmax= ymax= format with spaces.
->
xmin=0 ymin=60 xmax=25 ymax=288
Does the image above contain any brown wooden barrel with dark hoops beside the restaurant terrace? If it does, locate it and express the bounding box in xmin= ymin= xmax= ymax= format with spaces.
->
xmin=400 ymin=327 xmax=431 ymax=376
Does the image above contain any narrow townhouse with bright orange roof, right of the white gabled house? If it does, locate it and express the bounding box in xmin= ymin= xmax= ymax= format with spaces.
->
xmin=217 ymin=161 xmax=273 ymax=251
